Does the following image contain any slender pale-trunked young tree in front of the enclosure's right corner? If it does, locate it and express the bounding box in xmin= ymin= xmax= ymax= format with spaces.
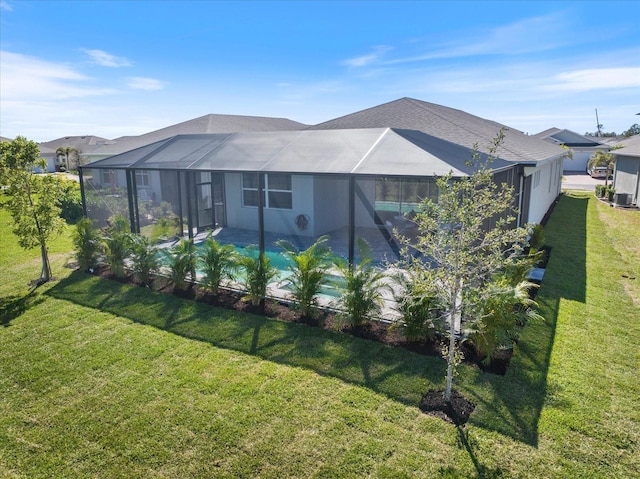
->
xmin=405 ymin=131 xmax=527 ymax=401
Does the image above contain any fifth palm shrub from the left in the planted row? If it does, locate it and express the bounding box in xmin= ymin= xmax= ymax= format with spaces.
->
xmin=198 ymin=236 xmax=239 ymax=294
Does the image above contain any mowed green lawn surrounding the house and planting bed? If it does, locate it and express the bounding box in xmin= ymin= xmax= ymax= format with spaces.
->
xmin=0 ymin=193 xmax=640 ymax=478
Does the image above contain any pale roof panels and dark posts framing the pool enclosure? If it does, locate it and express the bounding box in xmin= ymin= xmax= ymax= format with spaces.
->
xmin=79 ymin=128 xmax=522 ymax=265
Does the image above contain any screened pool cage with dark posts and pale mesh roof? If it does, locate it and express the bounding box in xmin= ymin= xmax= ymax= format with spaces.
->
xmin=80 ymin=129 xmax=516 ymax=264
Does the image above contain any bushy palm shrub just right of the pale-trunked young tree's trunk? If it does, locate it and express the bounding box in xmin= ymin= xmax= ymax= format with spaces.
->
xmin=466 ymin=276 xmax=543 ymax=364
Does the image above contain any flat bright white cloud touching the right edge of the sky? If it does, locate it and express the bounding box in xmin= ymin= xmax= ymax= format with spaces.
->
xmin=544 ymin=67 xmax=640 ymax=92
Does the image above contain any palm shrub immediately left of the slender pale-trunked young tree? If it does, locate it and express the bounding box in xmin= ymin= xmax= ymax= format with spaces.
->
xmin=393 ymin=271 xmax=445 ymax=341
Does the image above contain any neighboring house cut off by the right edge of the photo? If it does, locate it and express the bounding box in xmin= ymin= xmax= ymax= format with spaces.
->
xmin=611 ymin=135 xmax=640 ymax=206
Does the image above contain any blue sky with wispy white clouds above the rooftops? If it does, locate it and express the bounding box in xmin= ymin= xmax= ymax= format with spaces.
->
xmin=0 ymin=0 xmax=640 ymax=141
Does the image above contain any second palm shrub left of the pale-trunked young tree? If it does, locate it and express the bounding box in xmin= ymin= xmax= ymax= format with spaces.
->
xmin=335 ymin=238 xmax=392 ymax=326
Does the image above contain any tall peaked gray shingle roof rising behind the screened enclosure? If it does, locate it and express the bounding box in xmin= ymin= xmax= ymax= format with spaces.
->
xmin=310 ymin=98 xmax=565 ymax=163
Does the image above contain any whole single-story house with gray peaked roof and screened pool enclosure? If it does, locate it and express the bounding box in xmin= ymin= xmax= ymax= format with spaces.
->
xmin=82 ymin=98 xmax=566 ymax=258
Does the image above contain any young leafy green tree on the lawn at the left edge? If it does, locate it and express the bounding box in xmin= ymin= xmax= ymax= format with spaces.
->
xmin=0 ymin=136 xmax=64 ymax=284
